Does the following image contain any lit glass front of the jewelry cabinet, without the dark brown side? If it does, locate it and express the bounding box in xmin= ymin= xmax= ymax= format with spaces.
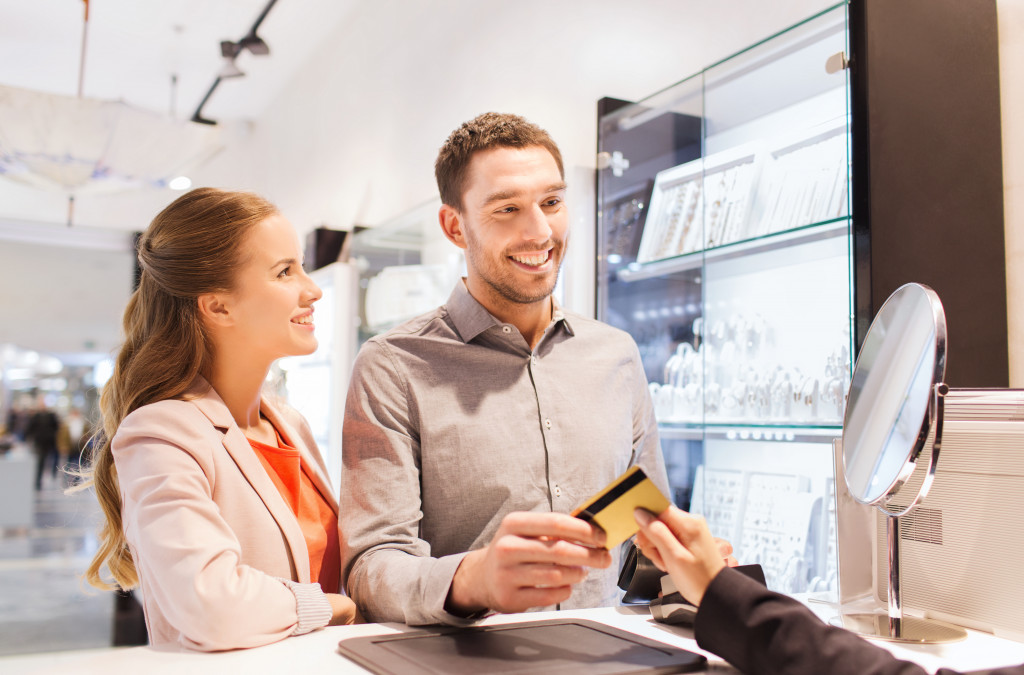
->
xmin=597 ymin=5 xmax=852 ymax=593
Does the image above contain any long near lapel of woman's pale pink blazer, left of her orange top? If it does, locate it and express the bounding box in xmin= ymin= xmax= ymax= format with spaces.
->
xmin=190 ymin=378 xmax=309 ymax=584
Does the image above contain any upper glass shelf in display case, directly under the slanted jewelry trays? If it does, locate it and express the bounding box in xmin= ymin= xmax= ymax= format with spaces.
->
xmin=615 ymin=216 xmax=850 ymax=283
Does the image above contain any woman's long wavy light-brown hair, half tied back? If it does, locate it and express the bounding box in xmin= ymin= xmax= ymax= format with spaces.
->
xmin=80 ymin=187 xmax=278 ymax=589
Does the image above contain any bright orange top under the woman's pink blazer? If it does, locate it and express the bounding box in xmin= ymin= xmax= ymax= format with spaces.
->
xmin=248 ymin=429 xmax=341 ymax=593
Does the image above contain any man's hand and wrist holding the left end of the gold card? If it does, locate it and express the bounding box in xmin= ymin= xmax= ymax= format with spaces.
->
xmin=445 ymin=512 xmax=611 ymax=616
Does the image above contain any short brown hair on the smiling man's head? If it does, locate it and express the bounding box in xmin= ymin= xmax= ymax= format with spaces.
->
xmin=434 ymin=113 xmax=565 ymax=210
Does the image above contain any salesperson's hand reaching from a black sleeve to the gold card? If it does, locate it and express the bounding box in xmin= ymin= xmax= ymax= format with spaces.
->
xmin=634 ymin=506 xmax=726 ymax=604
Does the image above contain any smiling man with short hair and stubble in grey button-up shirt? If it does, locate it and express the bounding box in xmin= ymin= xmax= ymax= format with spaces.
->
xmin=340 ymin=113 xmax=668 ymax=625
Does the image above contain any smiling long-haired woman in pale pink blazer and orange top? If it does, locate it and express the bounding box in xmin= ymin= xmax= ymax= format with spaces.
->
xmin=85 ymin=188 xmax=357 ymax=650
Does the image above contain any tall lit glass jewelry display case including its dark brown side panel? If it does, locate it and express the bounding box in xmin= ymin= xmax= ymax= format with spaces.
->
xmin=596 ymin=0 xmax=1009 ymax=592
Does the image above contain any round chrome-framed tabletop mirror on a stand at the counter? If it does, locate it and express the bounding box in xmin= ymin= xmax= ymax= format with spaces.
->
xmin=838 ymin=284 xmax=967 ymax=642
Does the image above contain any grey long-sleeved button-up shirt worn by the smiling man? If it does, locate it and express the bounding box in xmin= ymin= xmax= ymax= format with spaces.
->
xmin=339 ymin=283 xmax=668 ymax=625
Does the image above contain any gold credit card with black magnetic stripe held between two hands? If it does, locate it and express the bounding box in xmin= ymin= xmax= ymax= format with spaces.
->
xmin=572 ymin=466 xmax=671 ymax=549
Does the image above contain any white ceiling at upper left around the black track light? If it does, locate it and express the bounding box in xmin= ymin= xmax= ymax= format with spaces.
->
xmin=0 ymin=0 xmax=356 ymax=120
